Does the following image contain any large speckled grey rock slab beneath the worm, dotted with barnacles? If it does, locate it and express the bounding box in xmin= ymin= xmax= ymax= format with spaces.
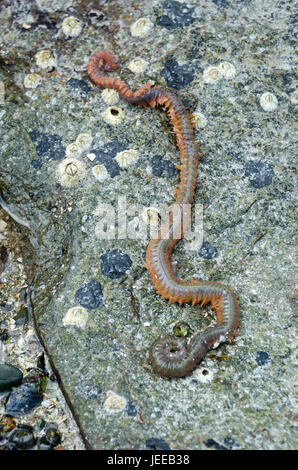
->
xmin=0 ymin=0 xmax=297 ymax=449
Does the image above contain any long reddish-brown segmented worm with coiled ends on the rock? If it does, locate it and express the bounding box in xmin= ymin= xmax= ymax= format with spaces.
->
xmin=88 ymin=50 xmax=239 ymax=378
